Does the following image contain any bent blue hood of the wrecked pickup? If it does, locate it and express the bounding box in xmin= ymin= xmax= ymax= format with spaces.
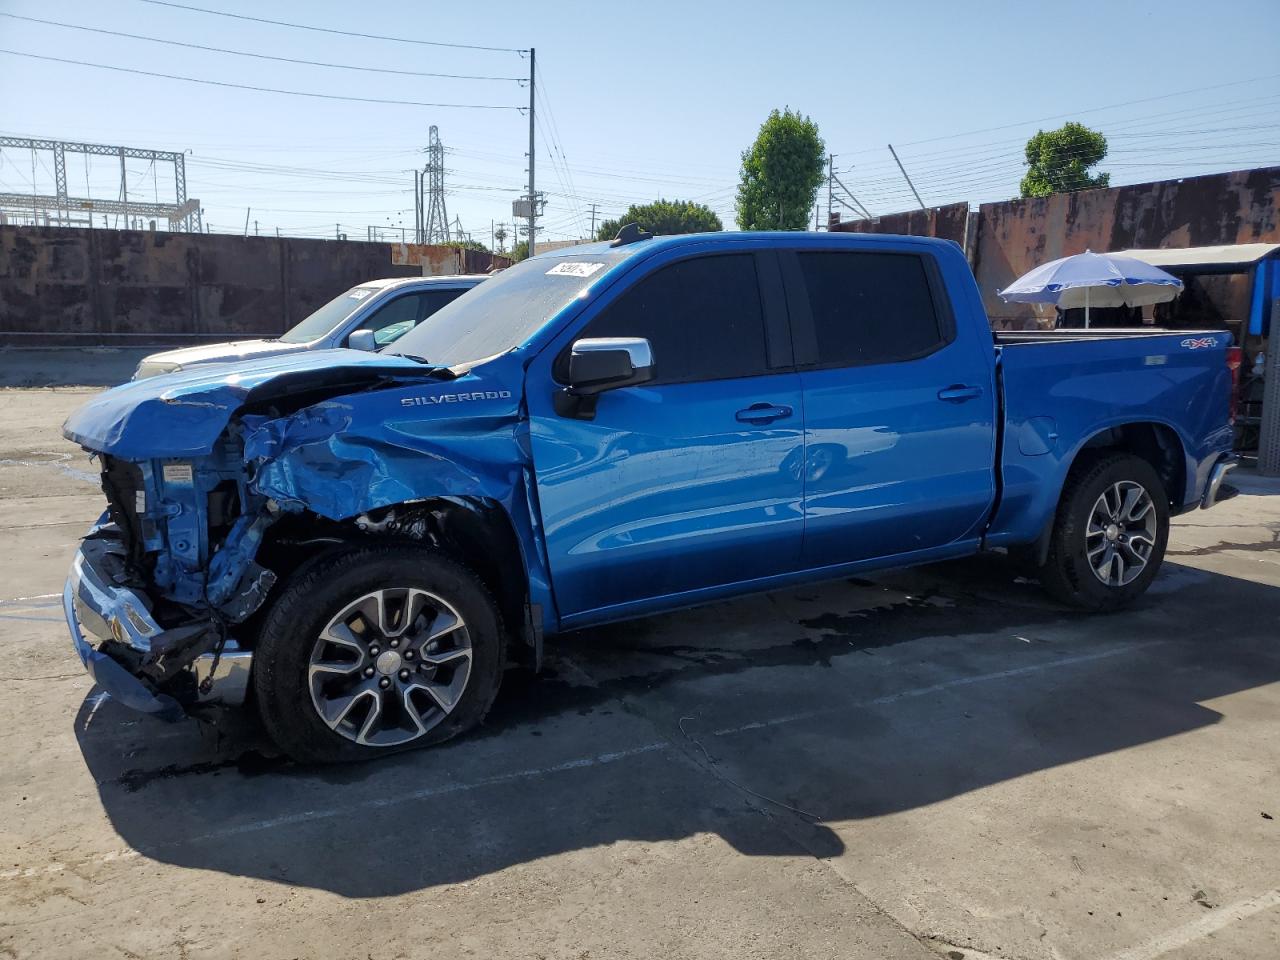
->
xmin=63 ymin=349 xmax=451 ymax=461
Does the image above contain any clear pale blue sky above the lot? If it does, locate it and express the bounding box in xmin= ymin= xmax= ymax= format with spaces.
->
xmin=0 ymin=0 xmax=1280 ymax=243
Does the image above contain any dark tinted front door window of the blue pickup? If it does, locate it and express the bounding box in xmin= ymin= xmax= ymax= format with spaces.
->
xmin=573 ymin=253 xmax=767 ymax=383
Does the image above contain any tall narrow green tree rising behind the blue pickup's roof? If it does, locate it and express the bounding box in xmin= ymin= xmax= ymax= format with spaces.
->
xmin=737 ymin=108 xmax=827 ymax=230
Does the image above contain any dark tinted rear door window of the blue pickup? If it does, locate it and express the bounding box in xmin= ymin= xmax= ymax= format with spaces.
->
xmin=799 ymin=252 xmax=942 ymax=366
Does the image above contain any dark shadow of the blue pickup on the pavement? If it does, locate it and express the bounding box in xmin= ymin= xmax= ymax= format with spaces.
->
xmin=76 ymin=558 xmax=1280 ymax=897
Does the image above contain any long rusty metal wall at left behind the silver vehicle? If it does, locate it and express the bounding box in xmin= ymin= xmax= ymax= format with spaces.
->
xmin=0 ymin=225 xmax=489 ymax=344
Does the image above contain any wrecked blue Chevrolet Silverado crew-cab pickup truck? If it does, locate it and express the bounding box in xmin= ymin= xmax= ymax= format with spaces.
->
xmin=64 ymin=228 xmax=1233 ymax=762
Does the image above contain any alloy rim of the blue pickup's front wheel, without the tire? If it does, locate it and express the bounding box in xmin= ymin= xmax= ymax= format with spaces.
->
xmin=307 ymin=588 xmax=471 ymax=746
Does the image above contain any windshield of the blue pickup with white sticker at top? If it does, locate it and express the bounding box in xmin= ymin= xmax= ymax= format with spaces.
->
xmin=387 ymin=250 xmax=628 ymax=366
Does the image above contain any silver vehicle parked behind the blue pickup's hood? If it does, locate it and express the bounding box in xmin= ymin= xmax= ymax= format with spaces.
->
xmin=133 ymin=275 xmax=485 ymax=380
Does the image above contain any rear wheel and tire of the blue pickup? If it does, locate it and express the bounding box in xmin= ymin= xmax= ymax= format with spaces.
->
xmin=1039 ymin=453 xmax=1169 ymax=611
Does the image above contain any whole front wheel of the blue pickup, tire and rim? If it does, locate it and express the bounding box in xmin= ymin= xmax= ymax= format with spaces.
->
xmin=253 ymin=545 xmax=506 ymax=763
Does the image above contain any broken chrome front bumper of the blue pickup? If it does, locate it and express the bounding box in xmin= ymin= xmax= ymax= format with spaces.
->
xmin=63 ymin=522 xmax=253 ymax=721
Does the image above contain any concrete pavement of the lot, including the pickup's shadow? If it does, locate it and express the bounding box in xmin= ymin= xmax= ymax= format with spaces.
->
xmin=0 ymin=389 xmax=1280 ymax=960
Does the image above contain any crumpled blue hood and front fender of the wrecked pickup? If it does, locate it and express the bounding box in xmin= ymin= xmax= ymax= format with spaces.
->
xmin=63 ymin=349 xmax=554 ymax=632
